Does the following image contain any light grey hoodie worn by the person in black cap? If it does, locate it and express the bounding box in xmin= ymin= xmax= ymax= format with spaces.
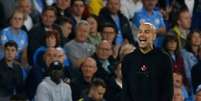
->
xmin=35 ymin=77 xmax=72 ymax=101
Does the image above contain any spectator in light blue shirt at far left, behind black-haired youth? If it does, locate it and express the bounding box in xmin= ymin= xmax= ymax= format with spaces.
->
xmin=0 ymin=10 xmax=28 ymax=64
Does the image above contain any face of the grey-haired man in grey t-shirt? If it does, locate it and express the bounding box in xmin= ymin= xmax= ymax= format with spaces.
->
xmin=76 ymin=25 xmax=89 ymax=42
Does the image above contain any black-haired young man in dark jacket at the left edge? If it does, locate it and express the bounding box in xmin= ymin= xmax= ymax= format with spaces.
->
xmin=0 ymin=41 xmax=24 ymax=101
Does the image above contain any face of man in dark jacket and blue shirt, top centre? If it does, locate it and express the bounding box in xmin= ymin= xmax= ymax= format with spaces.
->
xmin=108 ymin=0 xmax=120 ymax=14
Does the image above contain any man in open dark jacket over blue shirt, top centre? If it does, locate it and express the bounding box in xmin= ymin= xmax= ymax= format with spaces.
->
xmin=99 ymin=0 xmax=134 ymax=45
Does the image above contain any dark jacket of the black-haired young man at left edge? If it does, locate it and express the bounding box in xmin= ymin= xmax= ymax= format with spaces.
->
xmin=0 ymin=59 xmax=24 ymax=97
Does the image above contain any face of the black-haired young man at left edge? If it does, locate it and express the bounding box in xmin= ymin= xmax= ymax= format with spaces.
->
xmin=4 ymin=46 xmax=17 ymax=61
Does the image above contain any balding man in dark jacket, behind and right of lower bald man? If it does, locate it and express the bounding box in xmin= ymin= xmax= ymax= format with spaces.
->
xmin=92 ymin=40 xmax=115 ymax=82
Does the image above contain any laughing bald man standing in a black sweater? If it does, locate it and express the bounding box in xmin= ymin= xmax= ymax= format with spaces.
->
xmin=122 ymin=22 xmax=173 ymax=101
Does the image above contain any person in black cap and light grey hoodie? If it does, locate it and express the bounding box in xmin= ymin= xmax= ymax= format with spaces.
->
xmin=35 ymin=61 xmax=72 ymax=101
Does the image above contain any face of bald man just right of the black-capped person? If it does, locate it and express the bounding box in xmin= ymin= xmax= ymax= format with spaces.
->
xmin=81 ymin=58 xmax=97 ymax=78
